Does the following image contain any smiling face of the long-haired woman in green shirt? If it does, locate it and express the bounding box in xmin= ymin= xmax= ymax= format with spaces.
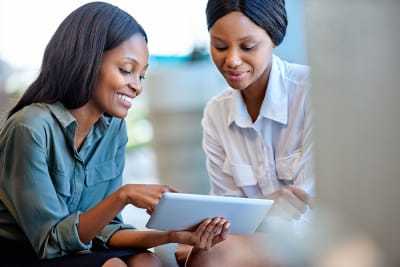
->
xmin=89 ymin=34 xmax=149 ymax=118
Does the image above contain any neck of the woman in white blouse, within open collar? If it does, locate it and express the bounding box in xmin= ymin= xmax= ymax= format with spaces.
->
xmin=242 ymin=66 xmax=271 ymax=122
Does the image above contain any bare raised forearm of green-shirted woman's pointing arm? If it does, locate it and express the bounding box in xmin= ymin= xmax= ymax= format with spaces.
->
xmin=78 ymin=186 xmax=126 ymax=243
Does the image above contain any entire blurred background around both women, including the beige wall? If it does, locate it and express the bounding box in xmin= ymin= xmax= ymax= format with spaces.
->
xmin=0 ymin=0 xmax=400 ymax=267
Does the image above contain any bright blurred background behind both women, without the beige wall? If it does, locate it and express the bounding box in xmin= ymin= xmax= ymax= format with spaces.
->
xmin=0 ymin=0 xmax=306 ymax=194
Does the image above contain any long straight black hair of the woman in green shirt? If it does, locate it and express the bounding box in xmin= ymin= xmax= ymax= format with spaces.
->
xmin=8 ymin=2 xmax=147 ymax=117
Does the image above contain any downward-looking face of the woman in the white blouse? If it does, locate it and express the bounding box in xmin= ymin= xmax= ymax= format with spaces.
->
xmin=210 ymin=11 xmax=274 ymax=90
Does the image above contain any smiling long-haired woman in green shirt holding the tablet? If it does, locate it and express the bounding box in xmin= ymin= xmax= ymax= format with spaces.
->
xmin=0 ymin=2 xmax=228 ymax=266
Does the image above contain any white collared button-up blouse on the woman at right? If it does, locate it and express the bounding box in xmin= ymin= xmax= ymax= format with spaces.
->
xmin=202 ymin=56 xmax=314 ymax=201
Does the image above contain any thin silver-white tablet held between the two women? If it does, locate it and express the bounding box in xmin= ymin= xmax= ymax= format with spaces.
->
xmin=146 ymin=192 xmax=273 ymax=234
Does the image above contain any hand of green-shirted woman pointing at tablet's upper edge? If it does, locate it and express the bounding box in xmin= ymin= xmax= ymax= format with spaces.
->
xmin=120 ymin=184 xmax=177 ymax=214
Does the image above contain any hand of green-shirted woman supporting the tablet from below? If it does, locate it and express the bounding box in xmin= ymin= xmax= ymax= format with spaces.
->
xmin=170 ymin=217 xmax=230 ymax=250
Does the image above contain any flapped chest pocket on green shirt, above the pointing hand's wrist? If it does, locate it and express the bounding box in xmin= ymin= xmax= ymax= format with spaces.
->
xmin=85 ymin=160 xmax=122 ymax=186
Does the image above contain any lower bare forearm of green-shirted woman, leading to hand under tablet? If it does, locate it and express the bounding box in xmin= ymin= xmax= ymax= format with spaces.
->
xmin=108 ymin=230 xmax=178 ymax=249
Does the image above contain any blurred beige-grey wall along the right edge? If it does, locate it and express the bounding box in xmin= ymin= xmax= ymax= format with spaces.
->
xmin=306 ymin=0 xmax=400 ymax=266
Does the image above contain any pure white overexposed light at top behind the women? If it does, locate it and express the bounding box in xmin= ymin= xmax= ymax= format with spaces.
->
xmin=0 ymin=0 xmax=208 ymax=69
